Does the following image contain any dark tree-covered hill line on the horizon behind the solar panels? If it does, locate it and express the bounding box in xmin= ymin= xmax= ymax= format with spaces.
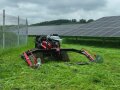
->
xmin=31 ymin=19 xmax=94 ymax=26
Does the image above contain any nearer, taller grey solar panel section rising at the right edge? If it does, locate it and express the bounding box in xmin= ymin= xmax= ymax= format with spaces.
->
xmin=74 ymin=16 xmax=120 ymax=37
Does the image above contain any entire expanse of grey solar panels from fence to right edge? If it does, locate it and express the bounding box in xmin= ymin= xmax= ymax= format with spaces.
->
xmin=29 ymin=16 xmax=120 ymax=37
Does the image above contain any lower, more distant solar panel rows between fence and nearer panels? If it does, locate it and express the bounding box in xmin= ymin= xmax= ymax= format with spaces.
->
xmin=28 ymin=24 xmax=82 ymax=36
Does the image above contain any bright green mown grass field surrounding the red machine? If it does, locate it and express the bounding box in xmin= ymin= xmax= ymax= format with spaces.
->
xmin=0 ymin=38 xmax=120 ymax=90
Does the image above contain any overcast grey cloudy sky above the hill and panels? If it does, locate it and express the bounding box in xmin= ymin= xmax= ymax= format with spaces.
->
xmin=0 ymin=0 xmax=120 ymax=23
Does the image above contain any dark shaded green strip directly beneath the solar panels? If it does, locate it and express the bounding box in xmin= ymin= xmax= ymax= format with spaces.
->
xmin=63 ymin=37 xmax=120 ymax=48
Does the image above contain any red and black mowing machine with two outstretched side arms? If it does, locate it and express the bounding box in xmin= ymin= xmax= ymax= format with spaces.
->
xmin=21 ymin=34 xmax=103 ymax=68
